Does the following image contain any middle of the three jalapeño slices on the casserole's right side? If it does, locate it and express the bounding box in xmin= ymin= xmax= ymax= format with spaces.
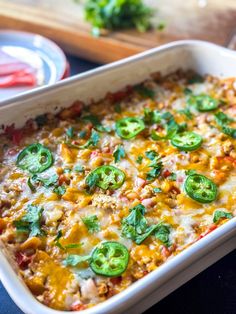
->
xmin=171 ymin=132 xmax=202 ymax=151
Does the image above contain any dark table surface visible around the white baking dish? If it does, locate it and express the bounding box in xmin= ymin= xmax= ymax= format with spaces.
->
xmin=0 ymin=56 xmax=236 ymax=314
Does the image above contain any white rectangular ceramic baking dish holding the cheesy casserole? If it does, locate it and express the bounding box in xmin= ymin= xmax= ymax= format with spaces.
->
xmin=0 ymin=41 xmax=236 ymax=314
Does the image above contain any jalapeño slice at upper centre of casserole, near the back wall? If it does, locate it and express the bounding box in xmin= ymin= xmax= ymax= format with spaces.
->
xmin=116 ymin=117 xmax=145 ymax=139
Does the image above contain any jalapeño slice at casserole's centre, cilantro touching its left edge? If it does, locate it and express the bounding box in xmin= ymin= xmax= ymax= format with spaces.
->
xmin=85 ymin=166 xmax=125 ymax=190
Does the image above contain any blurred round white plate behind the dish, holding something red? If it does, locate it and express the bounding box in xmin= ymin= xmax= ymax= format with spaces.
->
xmin=0 ymin=30 xmax=67 ymax=101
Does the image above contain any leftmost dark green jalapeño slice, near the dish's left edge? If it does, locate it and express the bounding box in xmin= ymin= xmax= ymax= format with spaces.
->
xmin=16 ymin=143 xmax=53 ymax=173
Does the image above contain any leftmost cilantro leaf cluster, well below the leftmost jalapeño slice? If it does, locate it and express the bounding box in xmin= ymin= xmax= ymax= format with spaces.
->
xmin=14 ymin=205 xmax=44 ymax=237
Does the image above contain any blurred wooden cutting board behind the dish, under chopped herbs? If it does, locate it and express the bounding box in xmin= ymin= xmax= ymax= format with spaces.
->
xmin=0 ymin=0 xmax=236 ymax=63
